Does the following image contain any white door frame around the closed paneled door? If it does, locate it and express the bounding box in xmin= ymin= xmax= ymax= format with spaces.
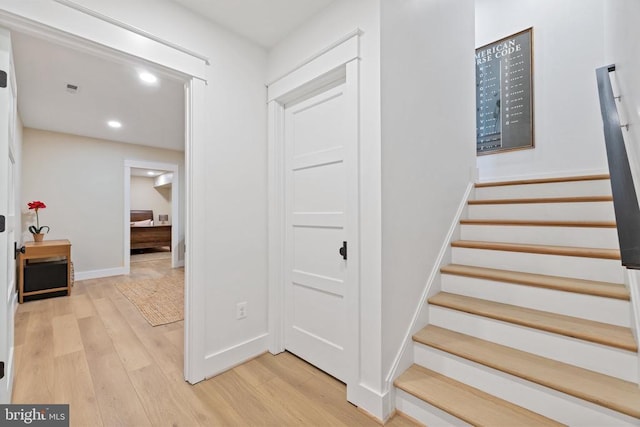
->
xmin=267 ymin=30 xmax=361 ymax=389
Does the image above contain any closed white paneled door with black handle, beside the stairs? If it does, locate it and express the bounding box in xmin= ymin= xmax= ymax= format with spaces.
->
xmin=284 ymin=77 xmax=357 ymax=382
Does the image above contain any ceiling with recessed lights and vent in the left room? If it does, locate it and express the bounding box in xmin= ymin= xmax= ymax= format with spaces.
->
xmin=12 ymin=33 xmax=184 ymax=150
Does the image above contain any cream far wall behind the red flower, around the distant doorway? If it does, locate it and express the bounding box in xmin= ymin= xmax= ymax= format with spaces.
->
xmin=21 ymin=128 xmax=184 ymax=278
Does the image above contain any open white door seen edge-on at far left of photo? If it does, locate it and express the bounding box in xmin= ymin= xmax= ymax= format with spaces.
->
xmin=0 ymin=29 xmax=16 ymax=403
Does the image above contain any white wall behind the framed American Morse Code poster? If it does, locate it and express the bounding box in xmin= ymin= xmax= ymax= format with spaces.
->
xmin=476 ymin=0 xmax=608 ymax=180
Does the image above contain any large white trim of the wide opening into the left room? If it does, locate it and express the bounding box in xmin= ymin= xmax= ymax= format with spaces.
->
xmin=0 ymin=6 xmax=211 ymax=384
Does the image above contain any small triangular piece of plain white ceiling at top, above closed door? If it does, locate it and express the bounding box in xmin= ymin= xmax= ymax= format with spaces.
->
xmin=172 ymin=0 xmax=334 ymax=48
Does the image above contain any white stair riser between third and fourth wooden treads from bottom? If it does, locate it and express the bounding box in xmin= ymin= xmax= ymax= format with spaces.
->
xmin=441 ymin=274 xmax=631 ymax=328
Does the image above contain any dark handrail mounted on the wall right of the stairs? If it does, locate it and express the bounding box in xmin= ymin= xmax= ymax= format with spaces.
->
xmin=596 ymin=65 xmax=640 ymax=269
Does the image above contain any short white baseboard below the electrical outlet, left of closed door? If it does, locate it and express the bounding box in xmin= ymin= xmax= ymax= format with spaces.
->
xmin=204 ymin=334 xmax=269 ymax=379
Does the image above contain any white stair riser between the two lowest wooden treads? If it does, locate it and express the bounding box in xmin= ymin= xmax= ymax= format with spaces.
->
xmin=414 ymin=344 xmax=640 ymax=427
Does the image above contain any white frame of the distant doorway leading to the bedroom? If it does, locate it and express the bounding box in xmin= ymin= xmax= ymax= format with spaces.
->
xmin=123 ymin=159 xmax=184 ymax=274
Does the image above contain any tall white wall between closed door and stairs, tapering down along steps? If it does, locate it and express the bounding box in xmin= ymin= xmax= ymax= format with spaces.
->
xmin=381 ymin=0 xmax=475 ymax=382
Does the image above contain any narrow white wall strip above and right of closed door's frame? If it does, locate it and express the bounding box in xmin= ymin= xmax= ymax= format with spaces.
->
xmin=267 ymin=0 xmax=383 ymax=416
